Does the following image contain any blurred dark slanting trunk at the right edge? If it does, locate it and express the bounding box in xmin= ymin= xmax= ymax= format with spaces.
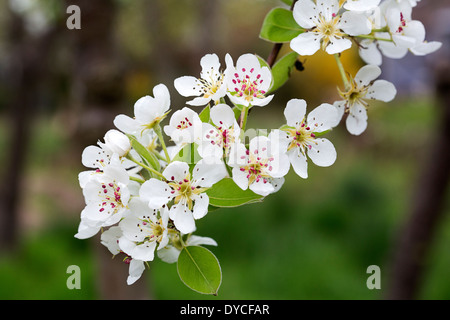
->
xmin=387 ymin=63 xmax=450 ymax=300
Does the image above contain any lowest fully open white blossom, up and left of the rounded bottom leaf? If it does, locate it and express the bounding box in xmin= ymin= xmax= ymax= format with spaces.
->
xmin=119 ymin=198 xmax=169 ymax=261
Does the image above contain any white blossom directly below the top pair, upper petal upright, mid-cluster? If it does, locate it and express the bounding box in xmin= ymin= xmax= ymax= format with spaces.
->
xmin=198 ymin=104 xmax=241 ymax=161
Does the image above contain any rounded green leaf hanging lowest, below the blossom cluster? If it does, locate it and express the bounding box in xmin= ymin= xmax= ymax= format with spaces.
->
xmin=177 ymin=246 xmax=222 ymax=296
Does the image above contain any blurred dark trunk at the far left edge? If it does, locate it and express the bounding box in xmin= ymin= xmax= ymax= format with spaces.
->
xmin=0 ymin=12 xmax=58 ymax=250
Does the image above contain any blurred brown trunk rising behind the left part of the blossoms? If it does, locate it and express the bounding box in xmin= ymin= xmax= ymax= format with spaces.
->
xmin=66 ymin=0 xmax=150 ymax=300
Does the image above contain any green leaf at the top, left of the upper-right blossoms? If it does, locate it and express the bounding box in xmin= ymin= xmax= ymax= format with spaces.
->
xmin=259 ymin=8 xmax=305 ymax=43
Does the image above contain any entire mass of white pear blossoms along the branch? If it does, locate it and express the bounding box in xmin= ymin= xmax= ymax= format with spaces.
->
xmin=75 ymin=0 xmax=439 ymax=292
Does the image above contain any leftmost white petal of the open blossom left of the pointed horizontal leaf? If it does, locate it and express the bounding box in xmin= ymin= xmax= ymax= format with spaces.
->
xmin=139 ymin=178 xmax=173 ymax=209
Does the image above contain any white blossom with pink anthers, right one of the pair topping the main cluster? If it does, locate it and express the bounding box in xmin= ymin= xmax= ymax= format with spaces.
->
xmin=225 ymin=53 xmax=273 ymax=107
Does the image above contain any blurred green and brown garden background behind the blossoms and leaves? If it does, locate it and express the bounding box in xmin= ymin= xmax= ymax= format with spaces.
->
xmin=0 ymin=0 xmax=450 ymax=299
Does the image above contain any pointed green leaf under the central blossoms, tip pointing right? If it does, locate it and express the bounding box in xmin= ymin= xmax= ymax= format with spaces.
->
xmin=206 ymin=178 xmax=264 ymax=208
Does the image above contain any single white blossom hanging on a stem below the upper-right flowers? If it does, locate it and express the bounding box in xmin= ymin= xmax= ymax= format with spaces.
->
xmin=334 ymin=65 xmax=397 ymax=135
